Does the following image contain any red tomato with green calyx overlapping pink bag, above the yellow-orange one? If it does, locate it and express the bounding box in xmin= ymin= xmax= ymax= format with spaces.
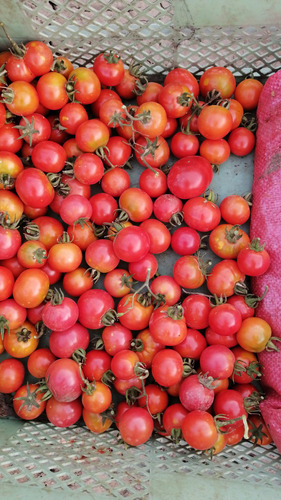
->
xmin=237 ymin=243 xmax=270 ymax=276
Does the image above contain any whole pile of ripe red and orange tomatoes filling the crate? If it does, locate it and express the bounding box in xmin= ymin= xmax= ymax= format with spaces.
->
xmin=0 ymin=31 xmax=276 ymax=453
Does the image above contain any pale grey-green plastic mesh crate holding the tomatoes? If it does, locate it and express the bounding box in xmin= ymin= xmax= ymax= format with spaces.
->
xmin=0 ymin=0 xmax=281 ymax=500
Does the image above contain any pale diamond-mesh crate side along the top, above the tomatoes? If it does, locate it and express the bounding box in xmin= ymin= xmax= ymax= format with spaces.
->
xmin=19 ymin=0 xmax=281 ymax=76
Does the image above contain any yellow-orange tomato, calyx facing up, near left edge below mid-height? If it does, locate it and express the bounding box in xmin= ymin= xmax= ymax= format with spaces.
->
xmin=3 ymin=321 xmax=39 ymax=358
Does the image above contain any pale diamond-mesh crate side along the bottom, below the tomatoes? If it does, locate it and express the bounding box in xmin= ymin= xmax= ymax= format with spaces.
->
xmin=0 ymin=423 xmax=281 ymax=500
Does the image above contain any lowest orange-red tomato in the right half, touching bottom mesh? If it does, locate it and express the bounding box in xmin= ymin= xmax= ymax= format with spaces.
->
xmin=182 ymin=410 xmax=218 ymax=450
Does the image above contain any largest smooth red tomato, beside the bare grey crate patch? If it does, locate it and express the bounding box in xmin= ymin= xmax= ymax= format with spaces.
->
xmin=167 ymin=156 xmax=213 ymax=200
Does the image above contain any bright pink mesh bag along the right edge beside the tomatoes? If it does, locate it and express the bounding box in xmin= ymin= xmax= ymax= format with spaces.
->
xmin=250 ymin=71 xmax=281 ymax=451
